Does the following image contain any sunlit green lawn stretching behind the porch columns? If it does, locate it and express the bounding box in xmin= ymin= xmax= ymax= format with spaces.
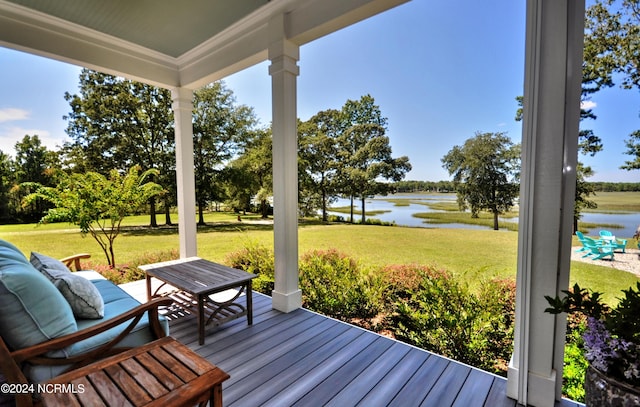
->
xmin=0 ymin=214 xmax=637 ymax=302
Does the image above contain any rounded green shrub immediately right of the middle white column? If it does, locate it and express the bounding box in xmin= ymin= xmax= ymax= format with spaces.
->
xmin=300 ymin=250 xmax=383 ymax=321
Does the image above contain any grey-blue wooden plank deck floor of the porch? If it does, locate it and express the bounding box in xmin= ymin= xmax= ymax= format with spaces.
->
xmin=146 ymin=294 xmax=579 ymax=407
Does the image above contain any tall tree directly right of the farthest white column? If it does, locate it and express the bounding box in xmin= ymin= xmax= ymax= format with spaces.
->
xmin=193 ymin=81 xmax=256 ymax=224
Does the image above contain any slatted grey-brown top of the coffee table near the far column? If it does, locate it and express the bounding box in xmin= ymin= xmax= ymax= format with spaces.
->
xmin=140 ymin=257 xmax=256 ymax=295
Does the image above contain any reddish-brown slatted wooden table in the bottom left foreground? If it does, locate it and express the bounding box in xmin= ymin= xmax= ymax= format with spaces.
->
xmin=41 ymin=336 xmax=229 ymax=407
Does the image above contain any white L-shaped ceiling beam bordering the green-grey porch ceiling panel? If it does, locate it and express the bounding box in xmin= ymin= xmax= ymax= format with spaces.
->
xmin=0 ymin=0 xmax=408 ymax=89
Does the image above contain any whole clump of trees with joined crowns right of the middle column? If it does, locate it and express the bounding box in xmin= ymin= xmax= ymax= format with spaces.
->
xmin=298 ymin=95 xmax=411 ymax=222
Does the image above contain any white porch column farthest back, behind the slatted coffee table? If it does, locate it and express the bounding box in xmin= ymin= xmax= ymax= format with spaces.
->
xmin=171 ymin=88 xmax=198 ymax=258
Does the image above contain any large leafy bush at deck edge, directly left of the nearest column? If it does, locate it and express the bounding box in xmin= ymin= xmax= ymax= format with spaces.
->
xmin=391 ymin=268 xmax=515 ymax=373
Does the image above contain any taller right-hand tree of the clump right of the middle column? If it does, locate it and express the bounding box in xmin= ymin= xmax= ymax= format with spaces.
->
xmin=338 ymin=95 xmax=411 ymax=223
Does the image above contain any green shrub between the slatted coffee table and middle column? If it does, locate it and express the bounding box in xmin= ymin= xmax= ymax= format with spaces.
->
xmin=224 ymin=242 xmax=275 ymax=295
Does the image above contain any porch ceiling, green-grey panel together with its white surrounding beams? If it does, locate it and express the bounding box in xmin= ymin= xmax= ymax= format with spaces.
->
xmin=0 ymin=0 xmax=408 ymax=88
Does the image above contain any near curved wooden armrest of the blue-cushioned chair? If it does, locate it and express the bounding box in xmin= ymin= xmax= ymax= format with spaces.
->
xmin=11 ymin=298 xmax=173 ymax=365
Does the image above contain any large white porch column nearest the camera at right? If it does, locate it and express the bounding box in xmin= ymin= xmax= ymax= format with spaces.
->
xmin=507 ymin=0 xmax=585 ymax=406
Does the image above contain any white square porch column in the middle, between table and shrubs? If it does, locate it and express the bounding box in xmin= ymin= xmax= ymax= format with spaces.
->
xmin=269 ymin=16 xmax=302 ymax=312
